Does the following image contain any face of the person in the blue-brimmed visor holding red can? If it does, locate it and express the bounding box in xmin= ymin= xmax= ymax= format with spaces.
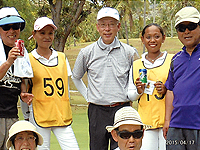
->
xmin=0 ymin=24 xmax=20 ymax=47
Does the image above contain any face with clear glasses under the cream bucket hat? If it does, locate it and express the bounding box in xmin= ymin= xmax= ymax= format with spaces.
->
xmin=14 ymin=131 xmax=36 ymax=150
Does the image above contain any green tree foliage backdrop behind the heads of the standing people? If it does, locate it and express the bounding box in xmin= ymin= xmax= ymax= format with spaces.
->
xmin=0 ymin=0 xmax=200 ymax=51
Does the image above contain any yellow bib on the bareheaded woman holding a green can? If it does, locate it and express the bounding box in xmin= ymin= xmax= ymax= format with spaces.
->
xmin=133 ymin=54 xmax=173 ymax=129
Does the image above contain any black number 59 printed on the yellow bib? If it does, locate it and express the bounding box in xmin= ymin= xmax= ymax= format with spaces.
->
xmin=44 ymin=78 xmax=64 ymax=96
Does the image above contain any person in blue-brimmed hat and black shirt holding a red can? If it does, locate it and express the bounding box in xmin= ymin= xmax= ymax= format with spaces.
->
xmin=0 ymin=7 xmax=33 ymax=150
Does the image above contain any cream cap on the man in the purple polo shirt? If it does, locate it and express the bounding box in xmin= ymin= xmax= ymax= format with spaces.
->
xmin=175 ymin=6 xmax=200 ymax=27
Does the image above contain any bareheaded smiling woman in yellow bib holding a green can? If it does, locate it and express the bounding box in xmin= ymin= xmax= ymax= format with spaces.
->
xmin=128 ymin=23 xmax=173 ymax=150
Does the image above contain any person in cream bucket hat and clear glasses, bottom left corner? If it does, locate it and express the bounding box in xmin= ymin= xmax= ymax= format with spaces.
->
xmin=6 ymin=120 xmax=43 ymax=150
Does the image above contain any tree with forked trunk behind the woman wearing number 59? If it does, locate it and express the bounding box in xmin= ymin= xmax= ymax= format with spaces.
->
xmin=31 ymin=0 xmax=97 ymax=51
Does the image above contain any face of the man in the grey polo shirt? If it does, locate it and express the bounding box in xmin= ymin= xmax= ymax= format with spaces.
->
xmin=96 ymin=17 xmax=120 ymax=44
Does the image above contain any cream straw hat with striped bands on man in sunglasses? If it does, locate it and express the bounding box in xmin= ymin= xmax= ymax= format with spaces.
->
xmin=106 ymin=106 xmax=144 ymax=132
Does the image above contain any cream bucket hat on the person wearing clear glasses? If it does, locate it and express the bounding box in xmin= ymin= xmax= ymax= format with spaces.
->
xmin=6 ymin=120 xmax=43 ymax=149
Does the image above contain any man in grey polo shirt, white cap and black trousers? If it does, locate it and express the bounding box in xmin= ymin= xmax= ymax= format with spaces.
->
xmin=72 ymin=7 xmax=138 ymax=150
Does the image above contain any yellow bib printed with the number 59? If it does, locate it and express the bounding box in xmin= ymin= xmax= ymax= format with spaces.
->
xmin=29 ymin=52 xmax=72 ymax=127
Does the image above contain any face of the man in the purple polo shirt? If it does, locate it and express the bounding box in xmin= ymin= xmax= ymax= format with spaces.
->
xmin=177 ymin=21 xmax=200 ymax=52
